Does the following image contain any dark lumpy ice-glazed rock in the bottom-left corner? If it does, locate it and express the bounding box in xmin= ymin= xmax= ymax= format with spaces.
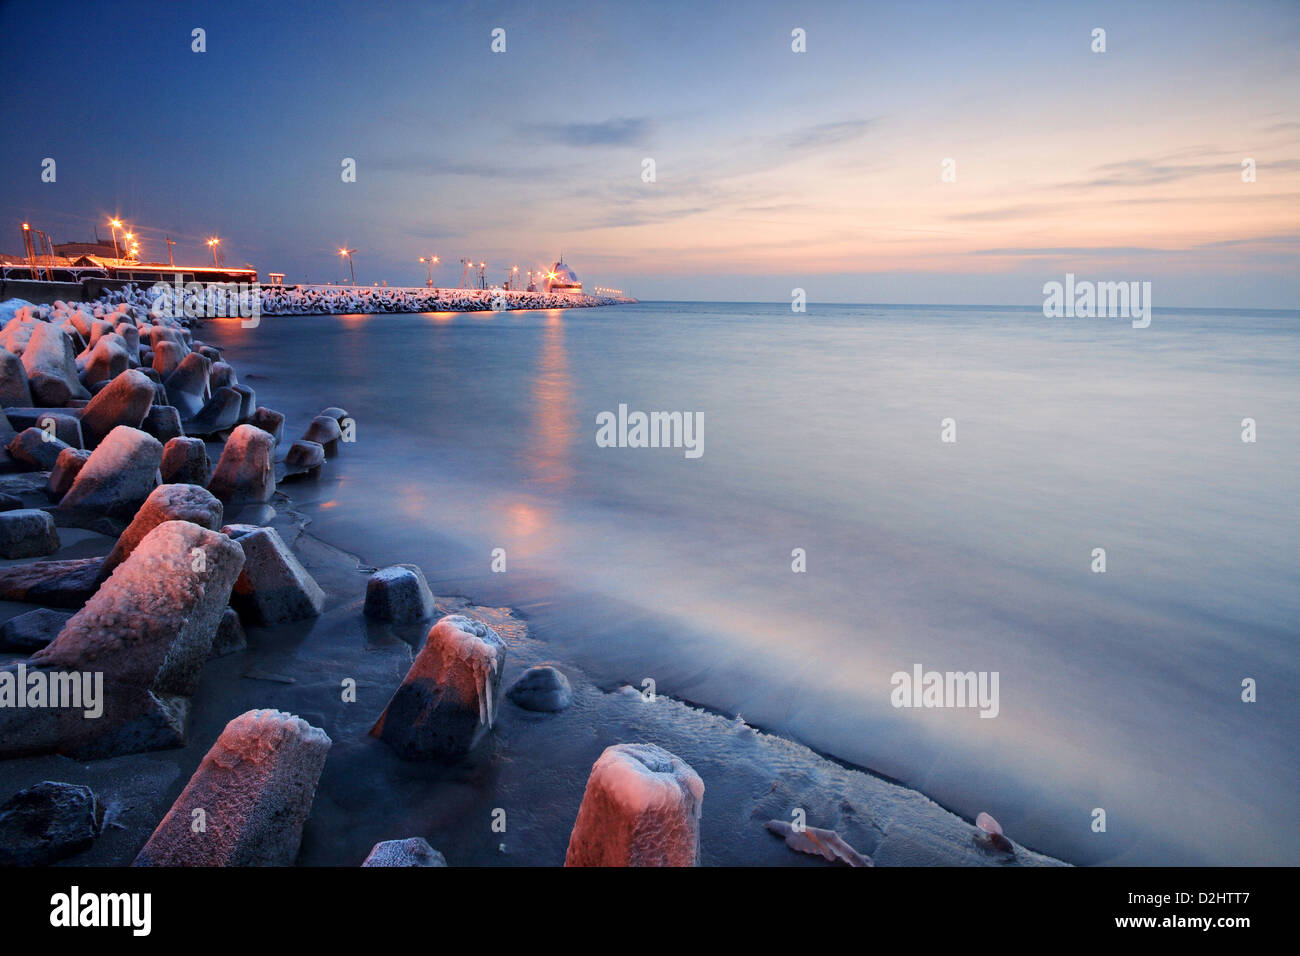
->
xmin=0 ymin=780 xmax=104 ymax=866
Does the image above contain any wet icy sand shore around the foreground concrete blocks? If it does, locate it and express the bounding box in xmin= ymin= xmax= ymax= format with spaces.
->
xmin=0 ymin=293 xmax=1062 ymax=866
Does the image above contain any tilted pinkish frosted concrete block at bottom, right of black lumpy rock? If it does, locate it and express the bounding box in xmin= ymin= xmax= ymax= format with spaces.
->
xmin=134 ymin=710 xmax=332 ymax=866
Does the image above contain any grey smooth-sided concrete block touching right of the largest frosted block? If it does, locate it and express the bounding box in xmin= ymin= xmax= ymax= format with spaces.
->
xmin=221 ymin=524 xmax=325 ymax=624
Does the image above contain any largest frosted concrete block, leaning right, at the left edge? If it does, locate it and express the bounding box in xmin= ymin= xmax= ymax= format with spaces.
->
xmin=0 ymin=522 xmax=243 ymax=760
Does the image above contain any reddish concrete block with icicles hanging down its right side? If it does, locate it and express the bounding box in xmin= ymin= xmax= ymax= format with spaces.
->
xmin=371 ymin=614 xmax=506 ymax=760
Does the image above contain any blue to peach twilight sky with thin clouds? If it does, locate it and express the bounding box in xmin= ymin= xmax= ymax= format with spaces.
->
xmin=0 ymin=0 xmax=1300 ymax=308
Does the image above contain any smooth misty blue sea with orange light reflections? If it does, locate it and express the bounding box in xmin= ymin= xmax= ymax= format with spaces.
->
xmin=200 ymin=303 xmax=1300 ymax=864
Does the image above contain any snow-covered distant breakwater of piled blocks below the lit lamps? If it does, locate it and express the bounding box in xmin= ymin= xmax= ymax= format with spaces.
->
xmin=261 ymin=286 xmax=636 ymax=315
